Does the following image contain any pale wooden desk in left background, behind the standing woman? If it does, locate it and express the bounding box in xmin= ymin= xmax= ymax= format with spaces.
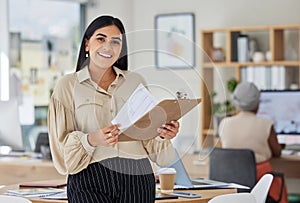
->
xmin=0 ymin=157 xmax=65 ymax=185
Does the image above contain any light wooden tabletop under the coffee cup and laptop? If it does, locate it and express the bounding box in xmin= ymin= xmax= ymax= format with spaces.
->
xmin=0 ymin=185 xmax=236 ymax=203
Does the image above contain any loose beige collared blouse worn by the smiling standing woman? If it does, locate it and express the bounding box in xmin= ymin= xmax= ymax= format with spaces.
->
xmin=48 ymin=67 xmax=174 ymax=175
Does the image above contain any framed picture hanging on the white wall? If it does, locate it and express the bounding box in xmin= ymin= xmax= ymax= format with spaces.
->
xmin=155 ymin=13 xmax=195 ymax=69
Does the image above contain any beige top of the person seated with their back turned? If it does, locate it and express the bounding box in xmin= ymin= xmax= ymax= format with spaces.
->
xmin=219 ymin=111 xmax=273 ymax=163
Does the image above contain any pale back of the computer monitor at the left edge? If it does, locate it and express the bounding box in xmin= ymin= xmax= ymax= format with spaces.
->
xmin=0 ymin=99 xmax=24 ymax=150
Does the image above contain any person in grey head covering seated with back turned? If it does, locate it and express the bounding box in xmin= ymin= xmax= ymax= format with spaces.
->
xmin=219 ymin=82 xmax=288 ymax=203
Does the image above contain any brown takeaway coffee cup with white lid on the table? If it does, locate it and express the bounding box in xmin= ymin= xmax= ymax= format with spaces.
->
xmin=157 ymin=168 xmax=176 ymax=193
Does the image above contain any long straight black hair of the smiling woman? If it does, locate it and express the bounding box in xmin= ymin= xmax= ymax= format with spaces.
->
xmin=76 ymin=16 xmax=128 ymax=72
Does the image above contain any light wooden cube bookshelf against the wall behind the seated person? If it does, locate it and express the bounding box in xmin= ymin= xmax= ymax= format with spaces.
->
xmin=200 ymin=25 xmax=300 ymax=146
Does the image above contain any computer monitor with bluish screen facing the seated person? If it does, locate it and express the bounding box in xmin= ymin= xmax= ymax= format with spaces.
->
xmin=257 ymin=90 xmax=300 ymax=144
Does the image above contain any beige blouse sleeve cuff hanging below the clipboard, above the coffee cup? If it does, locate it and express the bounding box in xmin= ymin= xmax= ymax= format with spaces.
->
xmin=142 ymin=136 xmax=175 ymax=166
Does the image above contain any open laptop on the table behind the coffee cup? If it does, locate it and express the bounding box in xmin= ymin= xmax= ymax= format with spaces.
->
xmin=169 ymin=151 xmax=230 ymax=189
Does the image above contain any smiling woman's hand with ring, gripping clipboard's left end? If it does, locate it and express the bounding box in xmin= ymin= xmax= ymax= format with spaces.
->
xmin=88 ymin=125 xmax=120 ymax=147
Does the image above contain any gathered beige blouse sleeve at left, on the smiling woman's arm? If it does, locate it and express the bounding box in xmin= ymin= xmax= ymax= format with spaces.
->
xmin=48 ymin=93 xmax=95 ymax=175
